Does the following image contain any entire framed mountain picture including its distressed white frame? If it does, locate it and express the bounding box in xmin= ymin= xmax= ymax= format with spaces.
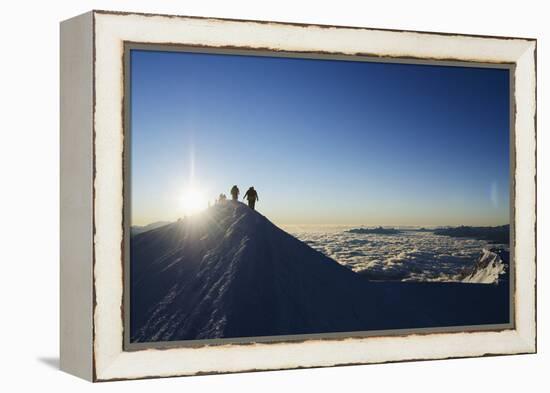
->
xmin=60 ymin=11 xmax=536 ymax=381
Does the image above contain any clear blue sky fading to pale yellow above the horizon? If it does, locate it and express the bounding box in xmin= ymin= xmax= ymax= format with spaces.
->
xmin=131 ymin=50 xmax=510 ymax=225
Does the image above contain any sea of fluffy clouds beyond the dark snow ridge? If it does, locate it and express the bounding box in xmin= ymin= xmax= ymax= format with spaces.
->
xmin=285 ymin=226 xmax=508 ymax=281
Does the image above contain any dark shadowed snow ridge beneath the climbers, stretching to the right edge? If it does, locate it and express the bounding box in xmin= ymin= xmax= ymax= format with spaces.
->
xmin=130 ymin=201 xmax=507 ymax=342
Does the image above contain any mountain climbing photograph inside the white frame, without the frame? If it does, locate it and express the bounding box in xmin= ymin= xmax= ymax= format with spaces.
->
xmin=124 ymin=44 xmax=514 ymax=348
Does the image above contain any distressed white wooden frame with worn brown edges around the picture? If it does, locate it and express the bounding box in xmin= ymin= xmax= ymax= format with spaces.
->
xmin=60 ymin=11 xmax=536 ymax=381
